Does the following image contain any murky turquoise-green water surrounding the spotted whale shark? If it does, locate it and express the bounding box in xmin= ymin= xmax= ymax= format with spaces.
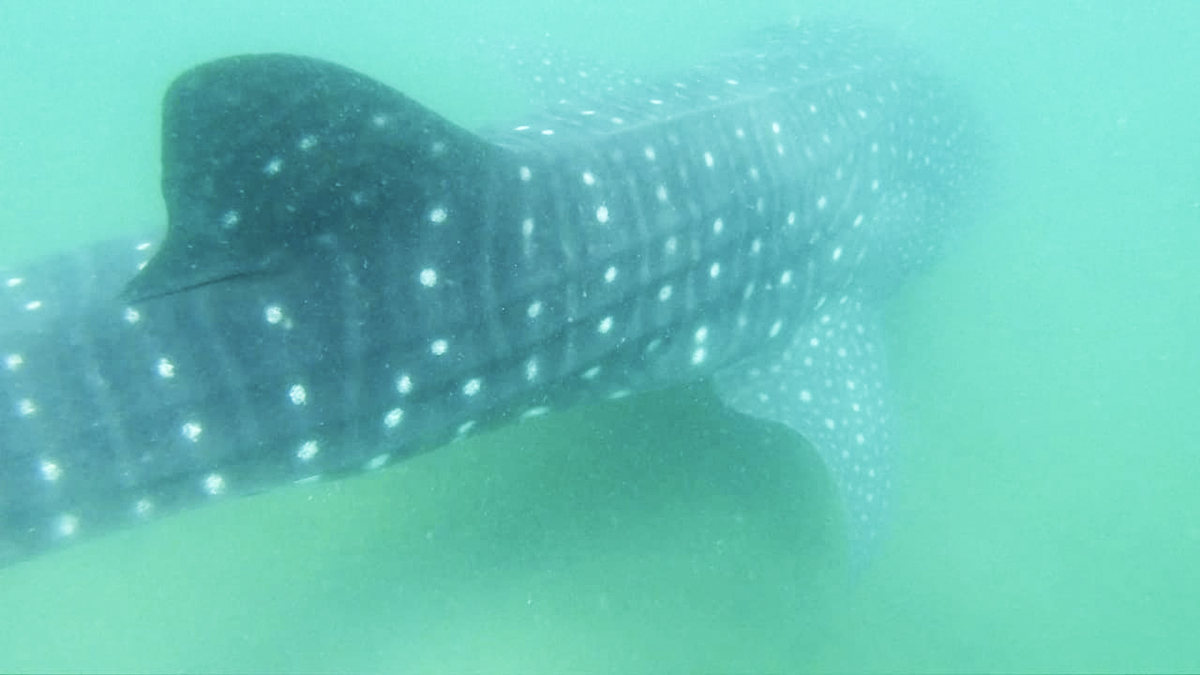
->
xmin=0 ymin=0 xmax=1200 ymax=673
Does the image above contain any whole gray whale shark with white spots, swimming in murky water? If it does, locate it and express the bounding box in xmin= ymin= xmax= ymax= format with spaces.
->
xmin=0 ymin=28 xmax=977 ymax=562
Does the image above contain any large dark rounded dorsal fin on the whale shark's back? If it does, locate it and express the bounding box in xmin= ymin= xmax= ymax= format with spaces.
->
xmin=125 ymin=54 xmax=490 ymax=300
